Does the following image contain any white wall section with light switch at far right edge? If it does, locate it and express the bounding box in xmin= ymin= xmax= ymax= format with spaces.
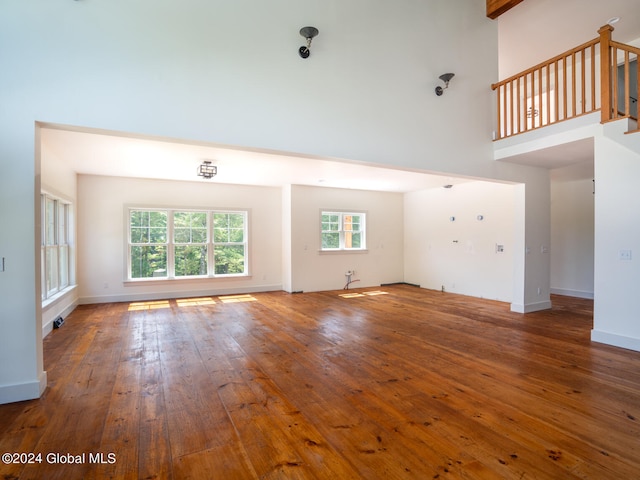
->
xmin=591 ymin=137 xmax=640 ymax=350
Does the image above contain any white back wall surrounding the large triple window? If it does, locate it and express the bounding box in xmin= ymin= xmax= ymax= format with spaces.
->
xmin=78 ymin=175 xmax=282 ymax=303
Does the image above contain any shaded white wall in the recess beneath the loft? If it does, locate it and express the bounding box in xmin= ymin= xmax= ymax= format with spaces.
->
xmin=551 ymin=162 xmax=595 ymax=298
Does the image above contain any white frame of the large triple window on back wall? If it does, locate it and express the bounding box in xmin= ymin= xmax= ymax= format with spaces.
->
xmin=124 ymin=205 xmax=251 ymax=282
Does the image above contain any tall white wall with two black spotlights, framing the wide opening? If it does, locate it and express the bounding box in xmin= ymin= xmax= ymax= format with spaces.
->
xmin=0 ymin=0 xmax=548 ymax=401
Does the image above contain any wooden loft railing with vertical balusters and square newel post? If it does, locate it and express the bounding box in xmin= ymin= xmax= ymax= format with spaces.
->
xmin=491 ymin=25 xmax=640 ymax=140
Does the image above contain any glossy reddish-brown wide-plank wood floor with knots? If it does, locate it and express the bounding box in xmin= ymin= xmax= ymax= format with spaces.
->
xmin=0 ymin=285 xmax=640 ymax=480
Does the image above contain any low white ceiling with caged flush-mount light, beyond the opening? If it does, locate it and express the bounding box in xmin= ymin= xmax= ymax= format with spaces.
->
xmin=40 ymin=125 xmax=473 ymax=193
